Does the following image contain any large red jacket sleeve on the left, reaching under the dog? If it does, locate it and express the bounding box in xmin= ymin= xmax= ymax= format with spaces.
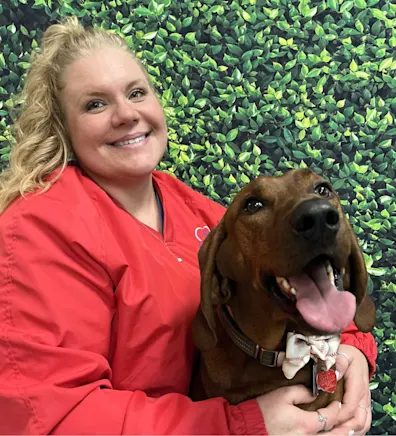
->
xmin=0 ymin=199 xmax=265 ymax=435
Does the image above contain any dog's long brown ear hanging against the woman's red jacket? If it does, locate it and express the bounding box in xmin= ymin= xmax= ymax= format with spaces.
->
xmin=193 ymin=218 xmax=230 ymax=351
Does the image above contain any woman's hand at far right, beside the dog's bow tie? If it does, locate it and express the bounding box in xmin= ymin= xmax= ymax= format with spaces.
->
xmin=329 ymin=344 xmax=372 ymax=435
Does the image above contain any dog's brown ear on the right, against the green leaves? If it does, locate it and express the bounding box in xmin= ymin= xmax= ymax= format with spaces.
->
xmin=348 ymin=227 xmax=376 ymax=333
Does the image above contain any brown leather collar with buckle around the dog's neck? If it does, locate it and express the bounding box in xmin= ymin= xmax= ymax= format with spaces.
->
xmin=218 ymin=304 xmax=285 ymax=368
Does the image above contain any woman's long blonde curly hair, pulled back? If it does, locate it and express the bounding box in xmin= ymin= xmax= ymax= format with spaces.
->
xmin=0 ymin=17 xmax=151 ymax=214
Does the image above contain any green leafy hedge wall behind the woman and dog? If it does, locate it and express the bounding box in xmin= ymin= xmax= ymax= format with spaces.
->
xmin=0 ymin=0 xmax=396 ymax=434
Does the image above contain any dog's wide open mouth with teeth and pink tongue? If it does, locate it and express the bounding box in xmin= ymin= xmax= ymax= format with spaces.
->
xmin=271 ymin=256 xmax=356 ymax=333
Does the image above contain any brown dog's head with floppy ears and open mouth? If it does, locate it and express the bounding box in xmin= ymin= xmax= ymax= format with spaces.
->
xmin=194 ymin=169 xmax=375 ymax=350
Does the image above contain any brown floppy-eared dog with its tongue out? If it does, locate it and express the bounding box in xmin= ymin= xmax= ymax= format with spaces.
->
xmin=191 ymin=169 xmax=375 ymax=410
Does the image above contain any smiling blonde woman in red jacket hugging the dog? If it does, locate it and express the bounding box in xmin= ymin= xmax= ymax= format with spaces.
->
xmin=0 ymin=19 xmax=376 ymax=434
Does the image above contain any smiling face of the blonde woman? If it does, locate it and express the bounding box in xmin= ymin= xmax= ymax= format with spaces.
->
xmin=61 ymin=47 xmax=167 ymax=186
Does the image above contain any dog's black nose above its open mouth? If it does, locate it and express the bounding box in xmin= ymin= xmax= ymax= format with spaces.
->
xmin=293 ymin=199 xmax=340 ymax=243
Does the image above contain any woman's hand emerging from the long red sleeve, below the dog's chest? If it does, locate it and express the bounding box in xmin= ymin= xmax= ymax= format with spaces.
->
xmin=257 ymin=385 xmax=342 ymax=435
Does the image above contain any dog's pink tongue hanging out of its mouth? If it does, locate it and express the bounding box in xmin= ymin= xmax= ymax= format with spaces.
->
xmin=288 ymin=263 xmax=356 ymax=333
